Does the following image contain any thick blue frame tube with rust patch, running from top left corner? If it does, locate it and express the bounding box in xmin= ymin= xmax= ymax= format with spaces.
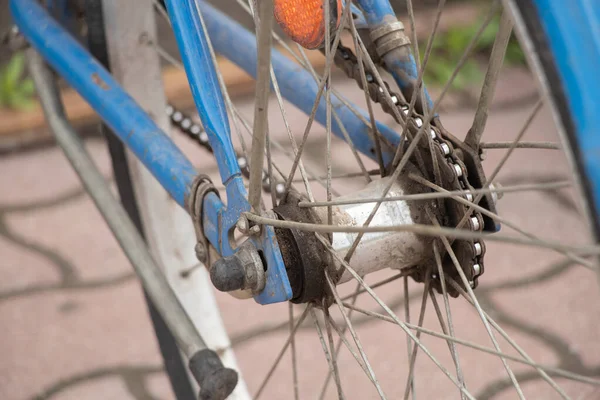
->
xmin=10 ymin=0 xmax=197 ymax=206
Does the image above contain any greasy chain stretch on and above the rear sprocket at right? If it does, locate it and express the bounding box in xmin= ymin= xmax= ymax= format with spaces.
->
xmin=334 ymin=43 xmax=485 ymax=296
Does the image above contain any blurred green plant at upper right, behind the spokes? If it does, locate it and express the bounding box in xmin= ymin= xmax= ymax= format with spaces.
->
xmin=419 ymin=15 xmax=525 ymax=90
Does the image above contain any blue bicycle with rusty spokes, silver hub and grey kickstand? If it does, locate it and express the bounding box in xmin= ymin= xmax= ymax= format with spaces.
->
xmin=11 ymin=0 xmax=600 ymax=399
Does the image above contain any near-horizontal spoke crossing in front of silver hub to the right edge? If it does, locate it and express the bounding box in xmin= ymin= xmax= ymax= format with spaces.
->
xmin=244 ymin=212 xmax=600 ymax=255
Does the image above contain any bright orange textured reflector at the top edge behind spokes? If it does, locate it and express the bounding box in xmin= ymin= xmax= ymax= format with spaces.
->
xmin=273 ymin=0 xmax=342 ymax=49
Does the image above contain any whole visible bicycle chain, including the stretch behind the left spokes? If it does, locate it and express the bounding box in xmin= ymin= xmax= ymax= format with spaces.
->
xmin=166 ymin=44 xmax=485 ymax=296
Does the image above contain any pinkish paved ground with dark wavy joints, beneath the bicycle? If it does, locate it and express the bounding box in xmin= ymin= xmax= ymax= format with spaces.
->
xmin=0 ymin=70 xmax=600 ymax=400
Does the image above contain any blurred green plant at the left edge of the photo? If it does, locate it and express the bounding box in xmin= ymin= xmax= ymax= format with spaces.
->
xmin=0 ymin=53 xmax=35 ymax=110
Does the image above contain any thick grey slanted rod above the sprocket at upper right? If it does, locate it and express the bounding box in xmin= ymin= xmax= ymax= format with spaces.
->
xmin=464 ymin=9 xmax=513 ymax=150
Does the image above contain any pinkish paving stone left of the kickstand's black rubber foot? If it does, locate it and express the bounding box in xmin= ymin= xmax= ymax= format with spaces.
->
xmin=0 ymin=281 xmax=161 ymax=399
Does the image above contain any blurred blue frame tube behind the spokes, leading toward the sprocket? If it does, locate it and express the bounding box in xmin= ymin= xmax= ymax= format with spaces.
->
xmin=201 ymin=2 xmax=400 ymax=161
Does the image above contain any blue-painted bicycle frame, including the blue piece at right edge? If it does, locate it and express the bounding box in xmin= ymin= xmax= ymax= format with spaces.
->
xmin=10 ymin=0 xmax=600 ymax=304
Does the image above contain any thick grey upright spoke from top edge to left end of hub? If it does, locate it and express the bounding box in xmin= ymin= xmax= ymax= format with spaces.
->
xmin=248 ymin=0 xmax=273 ymax=212
